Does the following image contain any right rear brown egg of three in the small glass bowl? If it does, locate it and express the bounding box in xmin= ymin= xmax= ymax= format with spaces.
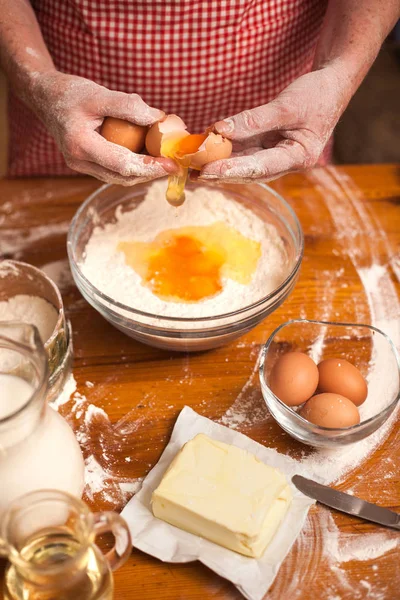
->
xmin=318 ymin=358 xmax=368 ymax=406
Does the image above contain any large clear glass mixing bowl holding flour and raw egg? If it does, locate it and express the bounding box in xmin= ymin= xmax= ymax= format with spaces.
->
xmin=67 ymin=183 xmax=304 ymax=351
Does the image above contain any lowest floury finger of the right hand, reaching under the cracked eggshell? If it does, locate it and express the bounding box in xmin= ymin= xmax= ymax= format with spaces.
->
xmin=199 ymin=144 xmax=308 ymax=181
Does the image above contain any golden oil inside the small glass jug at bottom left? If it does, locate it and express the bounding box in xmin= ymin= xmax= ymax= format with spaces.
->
xmin=5 ymin=527 xmax=113 ymax=600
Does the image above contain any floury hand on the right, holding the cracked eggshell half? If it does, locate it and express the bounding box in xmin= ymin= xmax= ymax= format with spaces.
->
xmin=199 ymin=67 xmax=351 ymax=183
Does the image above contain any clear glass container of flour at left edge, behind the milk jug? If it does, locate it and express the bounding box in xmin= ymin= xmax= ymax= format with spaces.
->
xmin=0 ymin=260 xmax=72 ymax=402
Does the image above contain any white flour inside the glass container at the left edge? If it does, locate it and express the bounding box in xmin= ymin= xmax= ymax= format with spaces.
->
xmin=0 ymin=294 xmax=58 ymax=343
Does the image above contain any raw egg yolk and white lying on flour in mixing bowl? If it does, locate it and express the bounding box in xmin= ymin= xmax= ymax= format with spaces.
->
xmin=117 ymin=222 xmax=261 ymax=302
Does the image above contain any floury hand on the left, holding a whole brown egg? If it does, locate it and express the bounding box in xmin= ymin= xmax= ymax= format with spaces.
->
xmin=30 ymin=71 xmax=177 ymax=185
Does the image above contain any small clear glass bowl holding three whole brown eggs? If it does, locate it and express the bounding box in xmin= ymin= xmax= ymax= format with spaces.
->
xmin=259 ymin=319 xmax=400 ymax=448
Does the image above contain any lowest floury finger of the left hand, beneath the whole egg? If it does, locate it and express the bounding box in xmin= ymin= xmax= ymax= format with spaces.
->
xmin=79 ymin=131 xmax=178 ymax=179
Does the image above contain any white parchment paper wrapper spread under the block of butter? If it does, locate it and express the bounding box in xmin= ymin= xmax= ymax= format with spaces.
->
xmin=122 ymin=406 xmax=316 ymax=600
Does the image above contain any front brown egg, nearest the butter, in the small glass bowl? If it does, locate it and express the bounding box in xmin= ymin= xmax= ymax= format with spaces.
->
xmin=299 ymin=394 xmax=360 ymax=429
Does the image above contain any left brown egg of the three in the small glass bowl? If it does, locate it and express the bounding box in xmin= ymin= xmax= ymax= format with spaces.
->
xmin=268 ymin=352 xmax=318 ymax=406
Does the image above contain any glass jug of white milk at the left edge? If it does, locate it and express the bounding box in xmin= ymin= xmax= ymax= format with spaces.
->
xmin=0 ymin=322 xmax=84 ymax=520
